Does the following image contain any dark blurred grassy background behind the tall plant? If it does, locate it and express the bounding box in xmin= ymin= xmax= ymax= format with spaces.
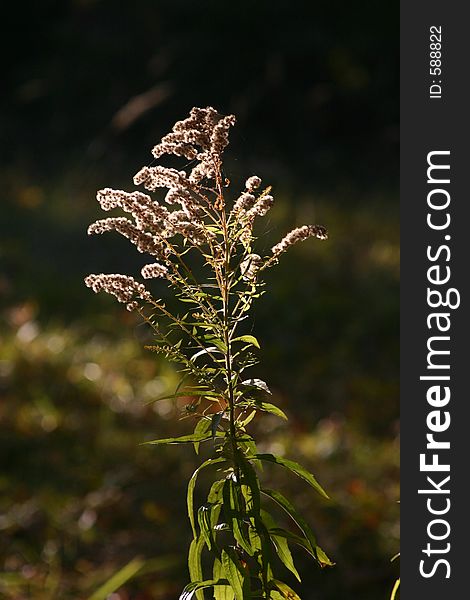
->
xmin=0 ymin=0 xmax=399 ymax=600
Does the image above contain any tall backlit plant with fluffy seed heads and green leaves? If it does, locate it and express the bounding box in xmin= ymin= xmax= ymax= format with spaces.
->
xmin=85 ymin=107 xmax=332 ymax=600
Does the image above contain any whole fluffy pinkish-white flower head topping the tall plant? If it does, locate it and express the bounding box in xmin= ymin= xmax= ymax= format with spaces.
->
xmin=86 ymin=107 xmax=327 ymax=308
